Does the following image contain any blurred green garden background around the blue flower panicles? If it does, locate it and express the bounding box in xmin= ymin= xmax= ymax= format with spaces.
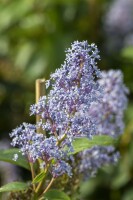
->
xmin=0 ymin=0 xmax=133 ymax=200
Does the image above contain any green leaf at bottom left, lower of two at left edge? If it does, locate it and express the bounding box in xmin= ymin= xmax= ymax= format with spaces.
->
xmin=0 ymin=182 xmax=28 ymax=192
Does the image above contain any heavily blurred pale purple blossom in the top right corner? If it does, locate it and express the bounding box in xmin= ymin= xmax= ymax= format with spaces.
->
xmin=103 ymin=0 xmax=133 ymax=53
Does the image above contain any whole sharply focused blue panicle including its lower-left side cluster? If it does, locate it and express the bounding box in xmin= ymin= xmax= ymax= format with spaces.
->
xmin=10 ymin=41 xmax=102 ymax=177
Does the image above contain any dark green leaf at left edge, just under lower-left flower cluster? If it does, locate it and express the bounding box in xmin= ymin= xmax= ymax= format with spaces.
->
xmin=0 ymin=148 xmax=30 ymax=170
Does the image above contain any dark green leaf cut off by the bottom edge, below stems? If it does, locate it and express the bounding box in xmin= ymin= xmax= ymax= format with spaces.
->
xmin=44 ymin=190 xmax=70 ymax=200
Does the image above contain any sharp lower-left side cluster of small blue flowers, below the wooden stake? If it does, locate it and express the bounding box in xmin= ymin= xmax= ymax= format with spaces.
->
xmin=10 ymin=123 xmax=71 ymax=177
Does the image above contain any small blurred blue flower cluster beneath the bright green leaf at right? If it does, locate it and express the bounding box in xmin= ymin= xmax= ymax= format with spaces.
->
xmin=79 ymin=146 xmax=120 ymax=178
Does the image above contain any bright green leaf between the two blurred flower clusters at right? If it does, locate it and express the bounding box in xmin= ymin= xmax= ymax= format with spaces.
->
xmin=72 ymin=135 xmax=117 ymax=154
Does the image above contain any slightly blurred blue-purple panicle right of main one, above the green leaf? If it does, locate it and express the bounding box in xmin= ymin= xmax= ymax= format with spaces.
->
xmin=89 ymin=70 xmax=128 ymax=137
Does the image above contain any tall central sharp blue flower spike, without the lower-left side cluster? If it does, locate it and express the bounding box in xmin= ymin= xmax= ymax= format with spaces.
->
xmin=31 ymin=41 xmax=102 ymax=141
